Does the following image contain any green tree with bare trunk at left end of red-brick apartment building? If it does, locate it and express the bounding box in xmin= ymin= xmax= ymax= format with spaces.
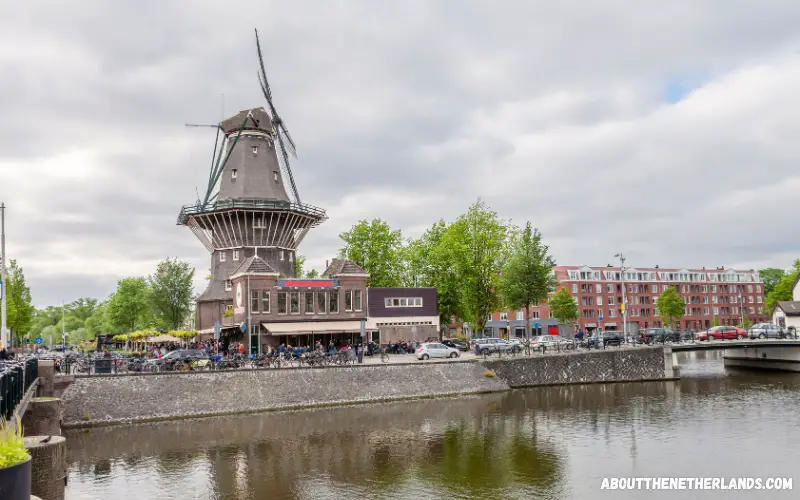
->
xmin=500 ymin=222 xmax=558 ymax=338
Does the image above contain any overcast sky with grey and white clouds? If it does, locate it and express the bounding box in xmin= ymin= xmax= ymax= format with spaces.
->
xmin=0 ymin=0 xmax=800 ymax=306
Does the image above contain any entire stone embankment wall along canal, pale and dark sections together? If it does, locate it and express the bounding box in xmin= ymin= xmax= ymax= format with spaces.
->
xmin=63 ymin=347 xmax=677 ymax=427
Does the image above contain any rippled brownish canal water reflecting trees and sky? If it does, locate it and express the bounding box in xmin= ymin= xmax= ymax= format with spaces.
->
xmin=67 ymin=351 xmax=800 ymax=500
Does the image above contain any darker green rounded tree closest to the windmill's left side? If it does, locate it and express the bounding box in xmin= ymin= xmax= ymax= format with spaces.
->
xmin=148 ymin=258 xmax=195 ymax=330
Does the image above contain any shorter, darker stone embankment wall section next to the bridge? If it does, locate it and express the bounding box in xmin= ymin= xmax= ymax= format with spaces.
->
xmin=484 ymin=347 xmax=678 ymax=387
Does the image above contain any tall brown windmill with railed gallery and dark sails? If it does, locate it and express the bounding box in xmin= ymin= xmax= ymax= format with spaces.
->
xmin=178 ymin=31 xmax=327 ymax=330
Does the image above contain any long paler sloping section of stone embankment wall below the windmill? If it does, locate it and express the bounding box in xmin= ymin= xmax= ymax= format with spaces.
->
xmin=64 ymin=362 xmax=509 ymax=427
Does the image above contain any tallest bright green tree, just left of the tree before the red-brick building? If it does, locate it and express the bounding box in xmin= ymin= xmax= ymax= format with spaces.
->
xmin=441 ymin=199 xmax=508 ymax=332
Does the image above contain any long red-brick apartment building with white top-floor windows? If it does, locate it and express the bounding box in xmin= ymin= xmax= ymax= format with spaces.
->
xmin=487 ymin=266 xmax=768 ymax=336
